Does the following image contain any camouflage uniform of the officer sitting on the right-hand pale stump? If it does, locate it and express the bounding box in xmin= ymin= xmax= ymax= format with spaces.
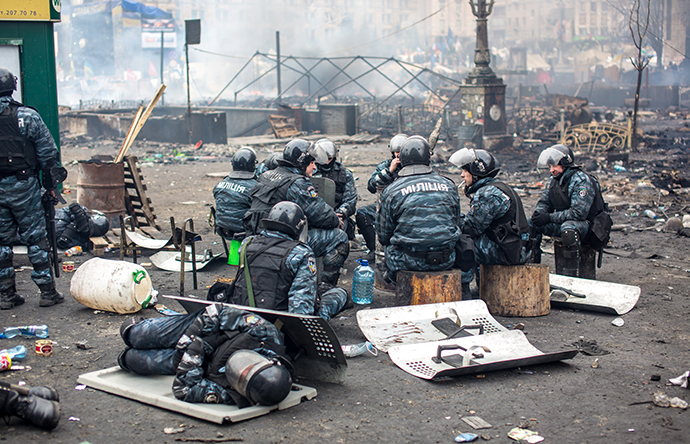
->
xmin=460 ymin=177 xmax=529 ymax=282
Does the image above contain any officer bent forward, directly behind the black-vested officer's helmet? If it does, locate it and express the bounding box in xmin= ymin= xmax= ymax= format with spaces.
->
xmin=244 ymin=139 xmax=350 ymax=291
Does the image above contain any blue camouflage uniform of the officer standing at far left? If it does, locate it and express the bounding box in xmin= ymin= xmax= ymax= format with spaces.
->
xmin=0 ymin=96 xmax=60 ymax=290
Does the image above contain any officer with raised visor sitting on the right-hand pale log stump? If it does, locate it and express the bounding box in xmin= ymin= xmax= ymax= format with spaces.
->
xmin=450 ymin=148 xmax=531 ymax=299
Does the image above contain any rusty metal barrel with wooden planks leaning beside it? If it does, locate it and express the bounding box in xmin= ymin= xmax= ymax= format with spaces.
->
xmin=77 ymin=161 xmax=126 ymax=227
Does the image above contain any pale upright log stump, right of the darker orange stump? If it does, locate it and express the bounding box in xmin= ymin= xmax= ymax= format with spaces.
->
xmin=479 ymin=264 xmax=551 ymax=317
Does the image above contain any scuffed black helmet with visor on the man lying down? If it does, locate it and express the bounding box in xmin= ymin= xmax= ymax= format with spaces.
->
xmin=225 ymin=349 xmax=292 ymax=405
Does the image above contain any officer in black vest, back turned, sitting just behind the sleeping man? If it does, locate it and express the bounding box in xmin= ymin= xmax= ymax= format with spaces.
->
xmin=223 ymin=202 xmax=348 ymax=320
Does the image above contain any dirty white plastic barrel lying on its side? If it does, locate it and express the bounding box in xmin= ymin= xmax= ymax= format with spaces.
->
xmin=69 ymin=257 xmax=153 ymax=314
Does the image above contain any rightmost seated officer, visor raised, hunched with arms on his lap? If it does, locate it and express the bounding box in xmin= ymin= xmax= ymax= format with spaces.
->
xmin=530 ymin=144 xmax=610 ymax=276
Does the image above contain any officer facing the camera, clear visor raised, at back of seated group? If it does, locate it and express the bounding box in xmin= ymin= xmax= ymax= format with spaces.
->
xmin=315 ymin=139 xmax=357 ymax=240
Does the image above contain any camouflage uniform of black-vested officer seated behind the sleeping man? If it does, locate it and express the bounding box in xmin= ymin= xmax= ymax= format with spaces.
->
xmin=228 ymin=230 xmax=347 ymax=320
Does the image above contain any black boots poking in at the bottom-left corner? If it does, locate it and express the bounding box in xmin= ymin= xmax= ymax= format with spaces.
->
xmin=0 ymin=382 xmax=60 ymax=430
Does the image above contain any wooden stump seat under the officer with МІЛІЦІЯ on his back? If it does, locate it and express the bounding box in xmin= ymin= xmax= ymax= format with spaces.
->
xmin=395 ymin=269 xmax=462 ymax=305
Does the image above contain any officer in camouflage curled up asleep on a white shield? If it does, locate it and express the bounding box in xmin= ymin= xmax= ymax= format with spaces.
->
xmin=117 ymin=304 xmax=292 ymax=408
